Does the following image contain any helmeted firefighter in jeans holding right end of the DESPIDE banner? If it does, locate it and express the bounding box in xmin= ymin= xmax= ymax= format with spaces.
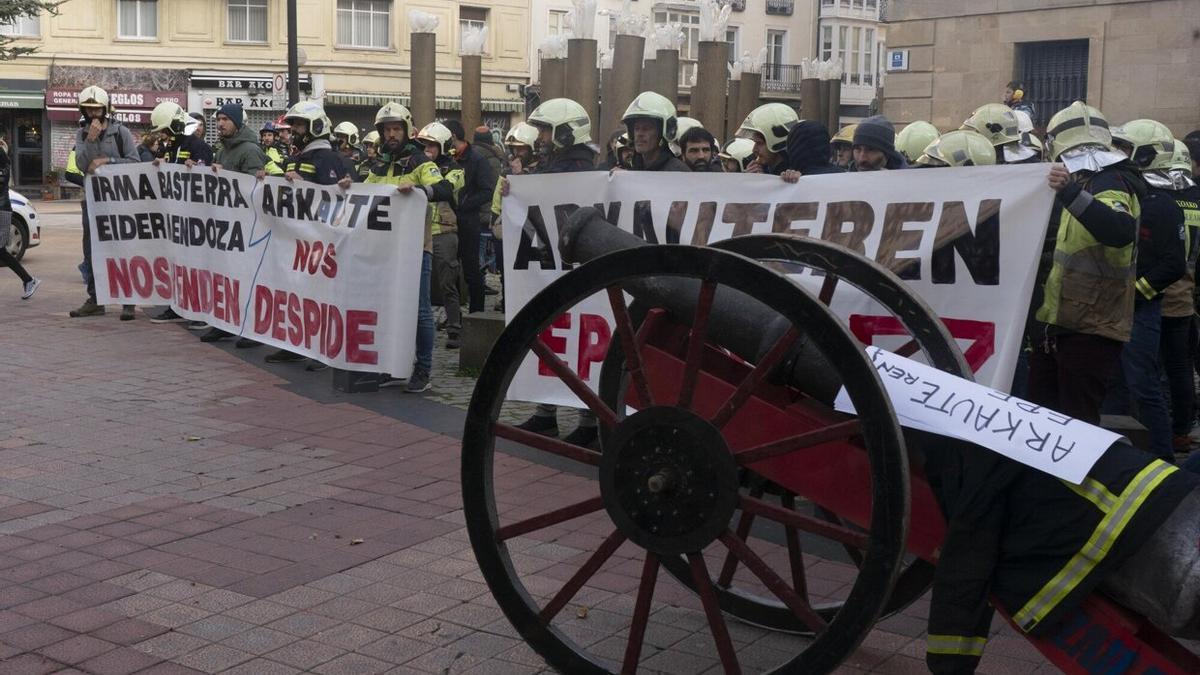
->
xmin=366 ymin=101 xmax=454 ymax=394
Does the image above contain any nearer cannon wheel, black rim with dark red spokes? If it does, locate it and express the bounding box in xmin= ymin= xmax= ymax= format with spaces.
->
xmin=462 ymin=245 xmax=910 ymax=674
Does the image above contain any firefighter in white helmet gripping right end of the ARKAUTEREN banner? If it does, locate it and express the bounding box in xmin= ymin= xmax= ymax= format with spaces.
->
xmin=1027 ymin=101 xmax=1142 ymax=424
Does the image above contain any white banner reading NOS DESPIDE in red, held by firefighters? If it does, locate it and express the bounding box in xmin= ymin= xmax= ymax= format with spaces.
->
xmin=86 ymin=165 xmax=427 ymax=377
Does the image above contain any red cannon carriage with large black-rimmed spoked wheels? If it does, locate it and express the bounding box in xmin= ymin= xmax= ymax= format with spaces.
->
xmin=462 ymin=210 xmax=1200 ymax=674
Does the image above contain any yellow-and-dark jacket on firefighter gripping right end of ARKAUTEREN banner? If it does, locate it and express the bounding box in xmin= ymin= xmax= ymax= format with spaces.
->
xmin=1037 ymin=167 xmax=1141 ymax=342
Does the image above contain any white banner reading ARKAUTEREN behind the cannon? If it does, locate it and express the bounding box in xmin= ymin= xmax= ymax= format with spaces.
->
xmin=503 ymin=165 xmax=1054 ymax=406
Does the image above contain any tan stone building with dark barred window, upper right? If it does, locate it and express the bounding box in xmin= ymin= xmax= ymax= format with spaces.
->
xmin=883 ymin=0 xmax=1200 ymax=137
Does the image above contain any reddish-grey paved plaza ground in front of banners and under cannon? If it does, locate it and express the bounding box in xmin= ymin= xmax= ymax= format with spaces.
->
xmin=0 ymin=218 xmax=1070 ymax=675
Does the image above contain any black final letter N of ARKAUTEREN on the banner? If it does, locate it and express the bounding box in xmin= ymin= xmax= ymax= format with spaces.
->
xmin=929 ymin=199 xmax=1000 ymax=286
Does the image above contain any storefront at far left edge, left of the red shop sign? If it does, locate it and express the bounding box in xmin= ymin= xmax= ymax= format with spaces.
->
xmin=0 ymin=79 xmax=49 ymax=190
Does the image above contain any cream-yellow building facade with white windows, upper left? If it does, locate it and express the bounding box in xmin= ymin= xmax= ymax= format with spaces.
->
xmin=0 ymin=0 xmax=530 ymax=186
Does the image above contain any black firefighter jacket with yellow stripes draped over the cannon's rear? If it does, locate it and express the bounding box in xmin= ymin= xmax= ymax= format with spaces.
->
xmin=905 ymin=430 xmax=1200 ymax=675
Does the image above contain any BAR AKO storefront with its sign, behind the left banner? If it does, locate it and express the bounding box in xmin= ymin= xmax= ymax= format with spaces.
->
xmin=188 ymin=71 xmax=312 ymax=143
